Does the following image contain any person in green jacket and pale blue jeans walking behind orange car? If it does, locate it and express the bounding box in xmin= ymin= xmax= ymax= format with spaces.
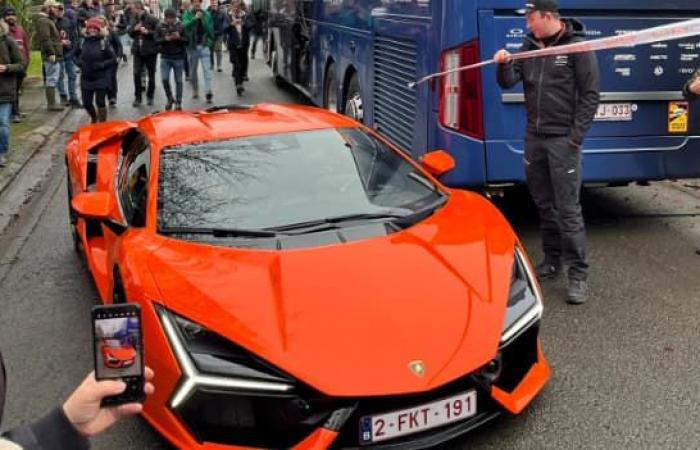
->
xmin=182 ymin=0 xmax=214 ymax=103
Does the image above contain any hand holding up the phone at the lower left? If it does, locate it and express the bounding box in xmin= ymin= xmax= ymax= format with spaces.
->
xmin=63 ymin=367 xmax=155 ymax=437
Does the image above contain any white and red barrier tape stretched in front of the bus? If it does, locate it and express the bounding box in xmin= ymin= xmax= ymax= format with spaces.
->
xmin=408 ymin=19 xmax=700 ymax=89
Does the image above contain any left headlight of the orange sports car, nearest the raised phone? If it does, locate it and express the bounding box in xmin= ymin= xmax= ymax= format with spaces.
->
xmin=158 ymin=308 xmax=294 ymax=408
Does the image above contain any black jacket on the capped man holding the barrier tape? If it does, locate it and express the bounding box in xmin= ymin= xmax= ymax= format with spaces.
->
xmin=498 ymin=19 xmax=600 ymax=146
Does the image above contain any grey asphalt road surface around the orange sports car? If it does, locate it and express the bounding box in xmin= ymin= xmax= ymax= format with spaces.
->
xmin=0 ymin=47 xmax=700 ymax=449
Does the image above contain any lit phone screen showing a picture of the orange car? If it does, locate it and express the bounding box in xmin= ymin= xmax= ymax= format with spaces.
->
xmin=95 ymin=317 xmax=141 ymax=379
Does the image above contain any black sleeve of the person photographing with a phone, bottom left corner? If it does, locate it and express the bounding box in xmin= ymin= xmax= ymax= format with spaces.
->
xmin=0 ymin=353 xmax=90 ymax=450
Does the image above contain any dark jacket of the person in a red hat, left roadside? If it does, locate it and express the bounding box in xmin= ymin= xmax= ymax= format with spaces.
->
xmin=76 ymin=36 xmax=117 ymax=90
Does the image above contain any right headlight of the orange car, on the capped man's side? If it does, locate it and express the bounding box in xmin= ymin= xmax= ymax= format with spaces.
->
xmin=501 ymin=247 xmax=543 ymax=345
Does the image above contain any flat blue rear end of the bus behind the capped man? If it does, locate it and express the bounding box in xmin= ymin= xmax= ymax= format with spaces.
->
xmin=479 ymin=7 xmax=700 ymax=184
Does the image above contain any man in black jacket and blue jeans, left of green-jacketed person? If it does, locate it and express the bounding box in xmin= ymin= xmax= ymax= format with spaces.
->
xmin=156 ymin=8 xmax=187 ymax=111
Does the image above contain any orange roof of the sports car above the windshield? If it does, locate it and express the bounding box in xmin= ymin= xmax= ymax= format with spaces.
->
xmin=138 ymin=104 xmax=358 ymax=148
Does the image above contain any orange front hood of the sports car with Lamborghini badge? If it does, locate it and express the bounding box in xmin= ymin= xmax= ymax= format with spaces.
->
xmin=149 ymin=191 xmax=516 ymax=396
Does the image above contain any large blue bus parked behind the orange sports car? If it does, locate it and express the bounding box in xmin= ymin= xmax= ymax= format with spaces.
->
xmin=268 ymin=0 xmax=700 ymax=187
